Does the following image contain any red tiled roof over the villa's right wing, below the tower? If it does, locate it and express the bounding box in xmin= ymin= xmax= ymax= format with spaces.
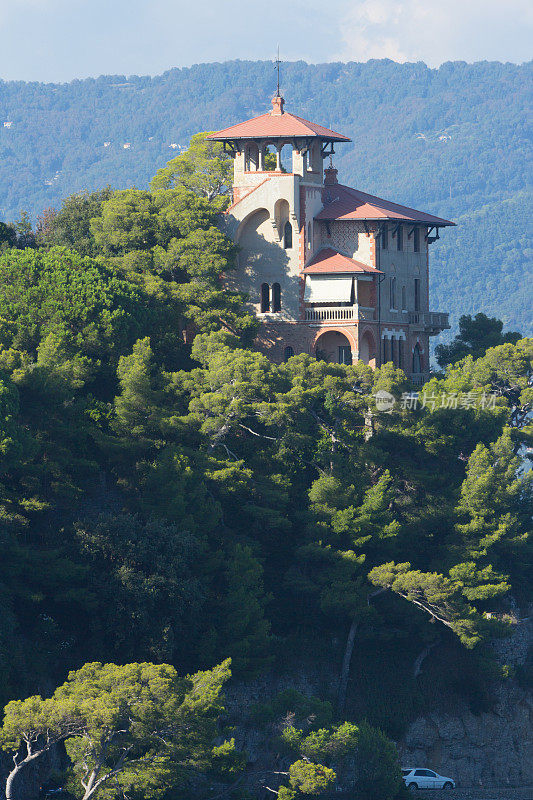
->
xmin=315 ymin=183 xmax=455 ymax=227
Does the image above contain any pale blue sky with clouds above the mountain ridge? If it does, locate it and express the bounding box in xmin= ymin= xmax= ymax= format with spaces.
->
xmin=0 ymin=0 xmax=533 ymax=82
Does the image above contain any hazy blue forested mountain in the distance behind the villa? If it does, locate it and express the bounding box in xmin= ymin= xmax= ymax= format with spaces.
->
xmin=0 ymin=60 xmax=533 ymax=334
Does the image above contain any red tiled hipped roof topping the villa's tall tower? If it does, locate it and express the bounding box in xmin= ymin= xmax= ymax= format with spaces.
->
xmin=207 ymin=111 xmax=351 ymax=142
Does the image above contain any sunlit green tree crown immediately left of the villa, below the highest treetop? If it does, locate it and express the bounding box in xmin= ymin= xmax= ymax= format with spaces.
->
xmin=91 ymin=186 xmax=256 ymax=341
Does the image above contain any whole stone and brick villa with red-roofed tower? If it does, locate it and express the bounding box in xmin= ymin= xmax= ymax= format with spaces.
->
xmin=209 ymin=94 xmax=454 ymax=383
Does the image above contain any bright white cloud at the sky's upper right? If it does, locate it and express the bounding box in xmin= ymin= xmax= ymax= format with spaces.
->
xmin=336 ymin=0 xmax=533 ymax=66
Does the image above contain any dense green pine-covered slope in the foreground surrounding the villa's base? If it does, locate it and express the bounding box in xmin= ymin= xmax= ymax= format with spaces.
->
xmin=0 ymin=139 xmax=533 ymax=800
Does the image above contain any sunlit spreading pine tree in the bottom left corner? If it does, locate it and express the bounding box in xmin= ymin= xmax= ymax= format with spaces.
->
xmin=0 ymin=661 xmax=230 ymax=800
